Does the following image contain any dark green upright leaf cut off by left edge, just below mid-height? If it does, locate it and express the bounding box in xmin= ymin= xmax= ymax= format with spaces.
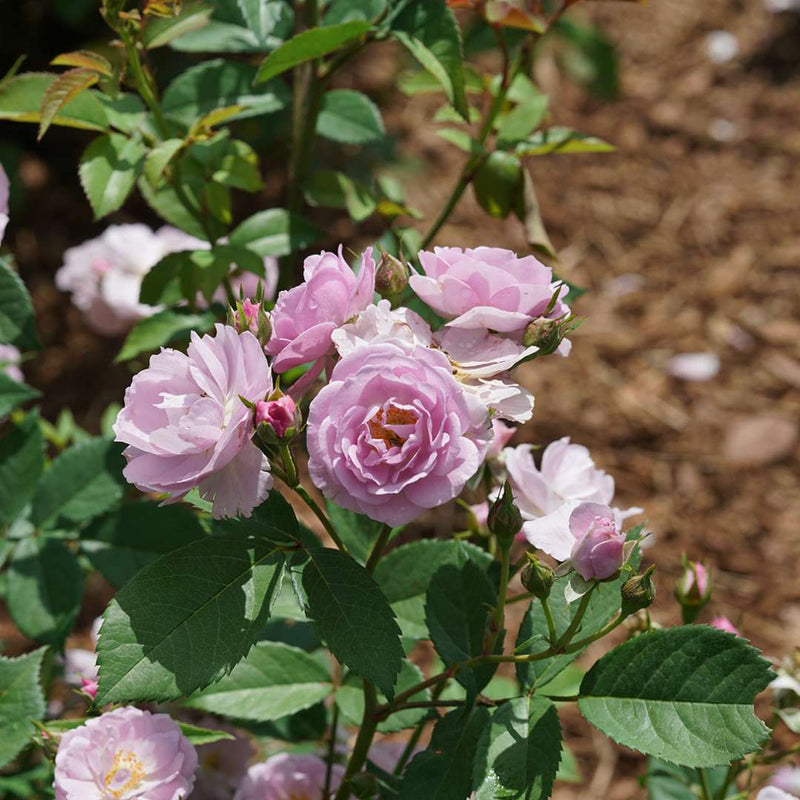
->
xmin=0 ymin=412 xmax=44 ymax=524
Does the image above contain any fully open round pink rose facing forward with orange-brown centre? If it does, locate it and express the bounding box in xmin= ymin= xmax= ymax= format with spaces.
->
xmin=307 ymin=342 xmax=491 ymax=526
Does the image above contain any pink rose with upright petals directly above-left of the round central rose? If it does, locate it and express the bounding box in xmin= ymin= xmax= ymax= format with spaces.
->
xmin=266 ymin=245 xmax=375 ymax=372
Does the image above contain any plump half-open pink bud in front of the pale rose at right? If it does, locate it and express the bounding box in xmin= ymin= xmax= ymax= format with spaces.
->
xmin=569 ymin=503 xmax=625 ymax=581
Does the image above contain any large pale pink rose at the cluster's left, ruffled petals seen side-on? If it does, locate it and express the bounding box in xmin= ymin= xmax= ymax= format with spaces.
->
xmin=114 ymin=324 xmax=272 ymax=518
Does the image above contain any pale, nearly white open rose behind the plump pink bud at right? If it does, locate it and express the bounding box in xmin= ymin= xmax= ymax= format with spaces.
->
xmin=505 ymin=436 xmax=641 ymax=560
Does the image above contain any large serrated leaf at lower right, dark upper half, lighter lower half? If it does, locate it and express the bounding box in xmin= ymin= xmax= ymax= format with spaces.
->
xmin=578 ymin=625 xmax=774 ymax=767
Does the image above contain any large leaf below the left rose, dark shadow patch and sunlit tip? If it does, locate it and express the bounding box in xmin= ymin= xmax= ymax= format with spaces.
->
xmin=97 ymin=533 xmax=284 ymax=705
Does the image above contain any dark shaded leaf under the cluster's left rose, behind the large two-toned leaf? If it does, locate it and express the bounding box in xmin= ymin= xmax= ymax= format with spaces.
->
xmin=81 ymin=502 xmax=206 ymax=588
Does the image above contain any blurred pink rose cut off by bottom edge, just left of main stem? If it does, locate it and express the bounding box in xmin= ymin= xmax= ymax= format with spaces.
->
xmin=233 ymin=753 xmax=344 ymax=800
